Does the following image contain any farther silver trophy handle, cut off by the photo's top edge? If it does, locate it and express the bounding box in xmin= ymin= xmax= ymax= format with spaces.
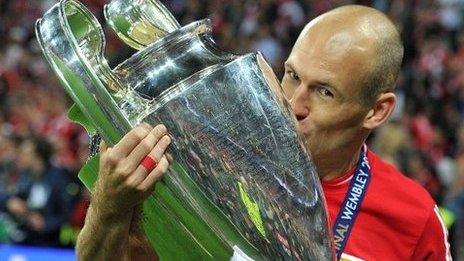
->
xmin=104 ymin=0 xmax=180 ymax=50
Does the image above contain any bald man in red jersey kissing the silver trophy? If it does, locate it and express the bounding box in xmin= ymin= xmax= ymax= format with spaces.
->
xmin=78 ymin=6 xmax=449 ymax=260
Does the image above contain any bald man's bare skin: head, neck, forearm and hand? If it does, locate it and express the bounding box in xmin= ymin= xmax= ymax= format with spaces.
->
xmin=77 ymin=6 xmax=403 ymax=260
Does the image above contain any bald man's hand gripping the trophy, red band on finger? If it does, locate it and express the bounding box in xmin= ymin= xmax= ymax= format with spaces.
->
xmin=93 ymin=123 xmax=171 ymax=217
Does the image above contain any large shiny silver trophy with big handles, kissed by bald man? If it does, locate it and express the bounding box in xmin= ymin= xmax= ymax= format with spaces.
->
xmin=37 ymin=0 xmax=333 ymax=260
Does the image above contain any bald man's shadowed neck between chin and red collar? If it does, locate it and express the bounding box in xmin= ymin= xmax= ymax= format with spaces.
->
xmin=314 ymin=144 xmax=361 ymax=180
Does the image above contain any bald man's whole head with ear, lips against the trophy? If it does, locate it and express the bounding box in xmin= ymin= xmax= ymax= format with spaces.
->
xmin=282 ymin=5 xmax=403 ymax=167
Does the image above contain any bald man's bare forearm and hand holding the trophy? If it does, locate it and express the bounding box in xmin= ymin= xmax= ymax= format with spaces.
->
xmin=76 ymin=124 xmax=171 ymax=260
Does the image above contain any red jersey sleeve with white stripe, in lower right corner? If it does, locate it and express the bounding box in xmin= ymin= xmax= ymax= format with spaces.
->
xmin=411 ymin=205 xmax=452 ymax=261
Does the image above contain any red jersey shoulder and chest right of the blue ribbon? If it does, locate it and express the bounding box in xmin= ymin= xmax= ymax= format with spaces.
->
xmin=346 ymin=151 xmax=444 ymax=260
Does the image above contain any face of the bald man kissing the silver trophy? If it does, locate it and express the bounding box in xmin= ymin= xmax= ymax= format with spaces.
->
xmin=282 ymin=26 xmax=373 ymax=162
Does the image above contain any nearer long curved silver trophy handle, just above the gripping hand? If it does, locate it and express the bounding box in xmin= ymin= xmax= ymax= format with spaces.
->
xmin=36 ymin=0 xmax=131 ymax=145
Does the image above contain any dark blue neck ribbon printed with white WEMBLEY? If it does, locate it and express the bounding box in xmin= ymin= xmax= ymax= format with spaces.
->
xmin=333 ymin=145 xmax=371 ymax=260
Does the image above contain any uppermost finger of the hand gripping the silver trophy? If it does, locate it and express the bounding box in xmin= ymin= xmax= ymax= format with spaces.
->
xmin=112 ymin=123 xmax=152 ymax=158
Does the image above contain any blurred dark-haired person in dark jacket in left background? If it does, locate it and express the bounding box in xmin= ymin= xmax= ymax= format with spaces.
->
xmin=0 ymin=137 xmax=71 ymax=246
